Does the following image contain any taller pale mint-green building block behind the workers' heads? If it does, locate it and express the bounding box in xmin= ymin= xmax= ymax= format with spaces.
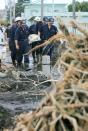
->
xmin=24 ymin=3 xmax=67 ymax=19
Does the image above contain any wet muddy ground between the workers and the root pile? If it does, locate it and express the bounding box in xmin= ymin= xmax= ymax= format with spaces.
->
xmin=0 ymin=43 xmax=61 ymax=131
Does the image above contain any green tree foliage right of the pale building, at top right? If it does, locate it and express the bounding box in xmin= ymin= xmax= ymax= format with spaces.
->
xmin=68 ymin=2 xmax=88 ymax=12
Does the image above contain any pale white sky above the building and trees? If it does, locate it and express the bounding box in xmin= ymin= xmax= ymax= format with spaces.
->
xmin=0 ymin=0 xmax=88 ymax=9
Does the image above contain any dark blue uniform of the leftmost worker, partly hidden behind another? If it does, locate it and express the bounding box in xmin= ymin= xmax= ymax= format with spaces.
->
xmin=9 ymin=24 xmax=17 ymax=65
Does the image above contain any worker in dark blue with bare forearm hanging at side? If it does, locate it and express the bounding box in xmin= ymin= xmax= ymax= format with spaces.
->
xmin=15 ymin=17 xmax=30 ymax=68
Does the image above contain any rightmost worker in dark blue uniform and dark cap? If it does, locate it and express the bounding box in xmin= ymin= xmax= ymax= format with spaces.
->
xmin=40 ymin=18 xmax=58 ymax=58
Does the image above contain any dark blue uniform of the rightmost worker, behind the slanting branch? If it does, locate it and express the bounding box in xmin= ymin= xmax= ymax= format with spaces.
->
xmin=40 ymin=24 xmax=58 ymax=56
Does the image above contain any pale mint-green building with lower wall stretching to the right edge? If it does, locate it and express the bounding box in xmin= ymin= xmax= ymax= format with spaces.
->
xmin=22 ymin=2 xmax=88 ymax=25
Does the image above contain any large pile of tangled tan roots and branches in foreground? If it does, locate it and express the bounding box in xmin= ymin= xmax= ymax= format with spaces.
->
xmin=6 ymin=22 xmax=88 ymax=131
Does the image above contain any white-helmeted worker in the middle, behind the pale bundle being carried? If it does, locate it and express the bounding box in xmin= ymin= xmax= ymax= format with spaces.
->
xmin=29 ymin=17 xmax=42 ymax=63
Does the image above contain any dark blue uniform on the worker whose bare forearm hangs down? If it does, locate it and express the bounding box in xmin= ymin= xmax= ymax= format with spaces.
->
xmin=15 ymin=25 xmax=30 ymax=65
